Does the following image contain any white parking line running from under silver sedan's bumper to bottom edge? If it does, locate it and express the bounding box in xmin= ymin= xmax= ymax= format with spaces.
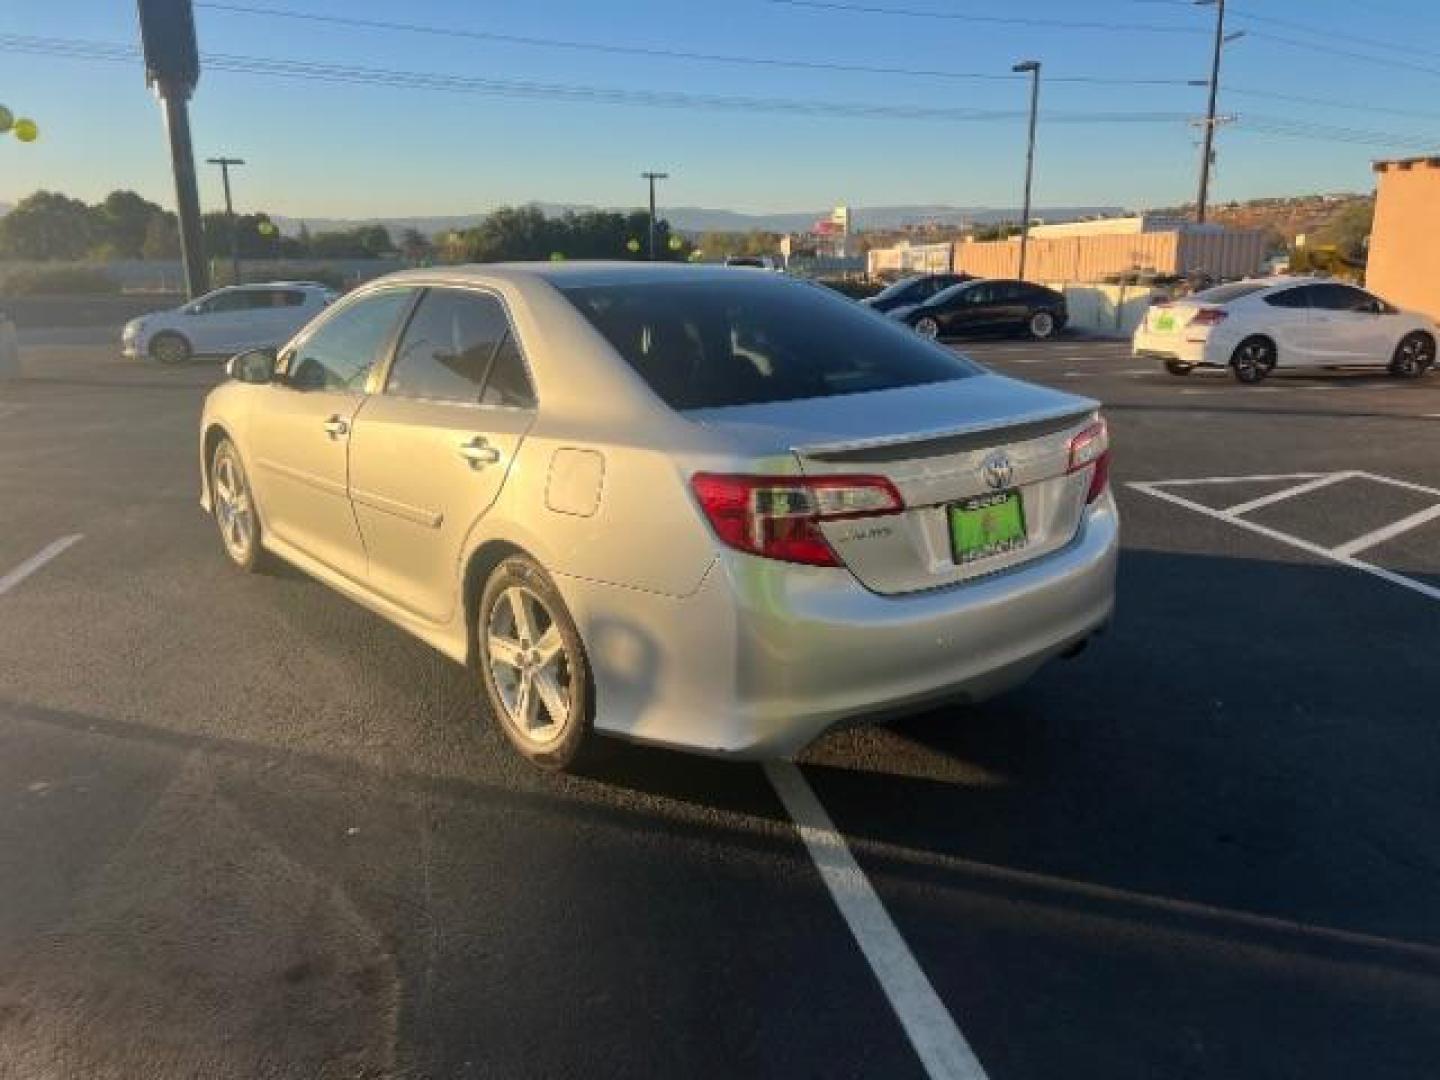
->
xmin=765 ymin=762 xmax=985 ymax=1080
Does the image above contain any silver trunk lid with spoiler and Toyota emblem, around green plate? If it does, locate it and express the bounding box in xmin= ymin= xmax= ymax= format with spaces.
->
xmin=685 ymin=374 xmax=1099 ymax=593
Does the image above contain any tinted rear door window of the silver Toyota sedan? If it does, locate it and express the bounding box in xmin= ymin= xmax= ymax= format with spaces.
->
xmin=386 ymin=289 xmax=510 ymax=405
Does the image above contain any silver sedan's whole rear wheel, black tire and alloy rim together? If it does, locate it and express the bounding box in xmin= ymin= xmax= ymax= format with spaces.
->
xmin=475 ymin=556 xmax=595 ymax=772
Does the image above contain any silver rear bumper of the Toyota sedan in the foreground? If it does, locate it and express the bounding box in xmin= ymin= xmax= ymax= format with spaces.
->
xmin=557 ymin=495 xmax=1119 ymax=757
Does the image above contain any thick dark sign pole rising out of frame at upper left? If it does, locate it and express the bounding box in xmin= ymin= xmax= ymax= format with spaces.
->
xmin=138 ymin=0 xmax=210 ymax=300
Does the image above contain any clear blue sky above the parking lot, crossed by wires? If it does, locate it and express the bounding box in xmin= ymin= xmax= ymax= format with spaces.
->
xmin=0 ymin=0 xmax=1440 ymax=216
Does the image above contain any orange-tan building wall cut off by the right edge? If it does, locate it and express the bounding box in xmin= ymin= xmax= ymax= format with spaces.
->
xmin=1365 ymin=157 xmax=1440 ymax=318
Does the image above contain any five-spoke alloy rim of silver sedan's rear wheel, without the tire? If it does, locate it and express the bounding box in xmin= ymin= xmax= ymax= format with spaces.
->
xmin=485 ymin=585 xmax=575 ymax=746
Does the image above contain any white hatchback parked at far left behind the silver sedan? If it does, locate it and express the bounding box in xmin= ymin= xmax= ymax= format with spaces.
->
xmin=121 ymin=281 xmax=337 ymax=364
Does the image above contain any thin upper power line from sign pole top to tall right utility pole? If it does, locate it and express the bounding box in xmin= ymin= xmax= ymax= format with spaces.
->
xmin=196 ymin=0 xmax=1189 ymax=86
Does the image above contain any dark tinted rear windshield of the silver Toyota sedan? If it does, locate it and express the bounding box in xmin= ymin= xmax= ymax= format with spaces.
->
xmin=560 ymin=275 xmax=982 ymax=409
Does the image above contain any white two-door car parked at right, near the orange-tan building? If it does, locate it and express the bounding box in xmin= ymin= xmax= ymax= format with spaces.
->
xmin=1135 ymin=278 xmax=1437 ymax=383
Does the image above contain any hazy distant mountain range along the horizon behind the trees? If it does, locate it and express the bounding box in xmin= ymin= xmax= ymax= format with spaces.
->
xmin=272 ymin=203 xmax=1122 ymax=236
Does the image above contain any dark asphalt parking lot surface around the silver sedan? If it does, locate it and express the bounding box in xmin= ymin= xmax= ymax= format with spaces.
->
xmin=0 ymin=337 xmax=1440 ymax=1080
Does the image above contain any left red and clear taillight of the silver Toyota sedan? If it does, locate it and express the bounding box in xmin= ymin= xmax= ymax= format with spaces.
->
xmin=690 ymin=472 xmax=904 ymax=566
